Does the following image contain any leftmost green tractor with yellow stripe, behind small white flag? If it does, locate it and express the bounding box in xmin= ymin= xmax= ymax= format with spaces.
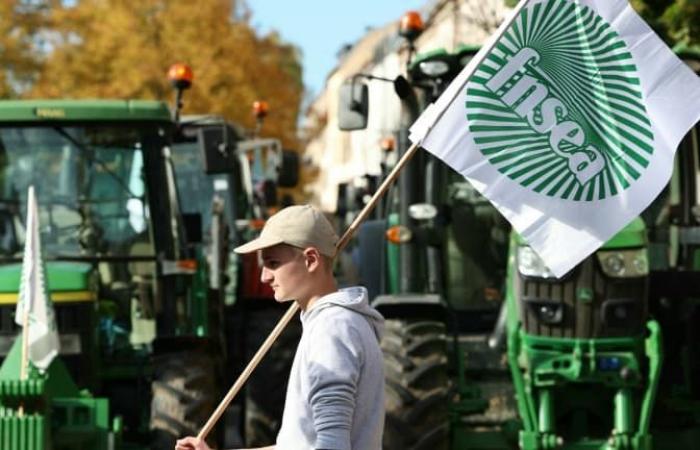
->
xmin=0 ymin=100 xmax=226 ymax=450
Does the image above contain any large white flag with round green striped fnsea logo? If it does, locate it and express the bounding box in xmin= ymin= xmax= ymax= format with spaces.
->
xmin=411 ymin=0 xmax=700 ymax=276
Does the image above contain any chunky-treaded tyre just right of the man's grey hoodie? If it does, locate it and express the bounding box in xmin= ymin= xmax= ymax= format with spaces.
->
xmin=381 ymin=319 xmax=450 ymax=450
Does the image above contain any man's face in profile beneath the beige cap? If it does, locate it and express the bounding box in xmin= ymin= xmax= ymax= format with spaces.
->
xmin=260 ymin=245 xmax=309 ymax=302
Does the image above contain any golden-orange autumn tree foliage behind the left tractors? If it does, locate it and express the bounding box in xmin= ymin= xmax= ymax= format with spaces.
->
xmin=0 ymin=0 xmax=303 ymax=146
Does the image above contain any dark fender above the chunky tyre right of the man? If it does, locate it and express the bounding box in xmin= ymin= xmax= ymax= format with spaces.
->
xmin=372 ymin=293 xmax=448 ymax=322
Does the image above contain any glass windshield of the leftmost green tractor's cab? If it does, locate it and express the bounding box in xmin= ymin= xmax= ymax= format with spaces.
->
xmin=0 ymin=124 xmax=150 ymax=257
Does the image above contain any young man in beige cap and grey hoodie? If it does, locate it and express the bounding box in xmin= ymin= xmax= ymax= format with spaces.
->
xmin=175 ymin=205 xmax=384 ymax=450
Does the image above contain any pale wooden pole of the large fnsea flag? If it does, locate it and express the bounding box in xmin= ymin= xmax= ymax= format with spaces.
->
xmin=197 ymin=143 xmax=419 ymax=441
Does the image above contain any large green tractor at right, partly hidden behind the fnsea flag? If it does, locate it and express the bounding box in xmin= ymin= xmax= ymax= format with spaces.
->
xmin=339 ymin=8 xmax=700 ymax=450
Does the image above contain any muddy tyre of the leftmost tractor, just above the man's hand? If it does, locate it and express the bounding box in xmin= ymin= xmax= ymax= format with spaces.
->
xmin=150 ymin=352 xmax=220 ymax=450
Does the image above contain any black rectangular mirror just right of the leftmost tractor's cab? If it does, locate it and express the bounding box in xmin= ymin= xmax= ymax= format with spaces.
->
xmin=197 ymin=125 xmax=236 ymax=174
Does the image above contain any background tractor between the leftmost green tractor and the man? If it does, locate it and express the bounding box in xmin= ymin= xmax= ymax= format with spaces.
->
xmin=173 ymin=109 xmax=301 ymax=447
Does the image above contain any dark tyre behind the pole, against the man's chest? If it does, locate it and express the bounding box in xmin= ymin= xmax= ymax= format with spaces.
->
xmin=244 ymin=308 xmax=301 ymax=447
